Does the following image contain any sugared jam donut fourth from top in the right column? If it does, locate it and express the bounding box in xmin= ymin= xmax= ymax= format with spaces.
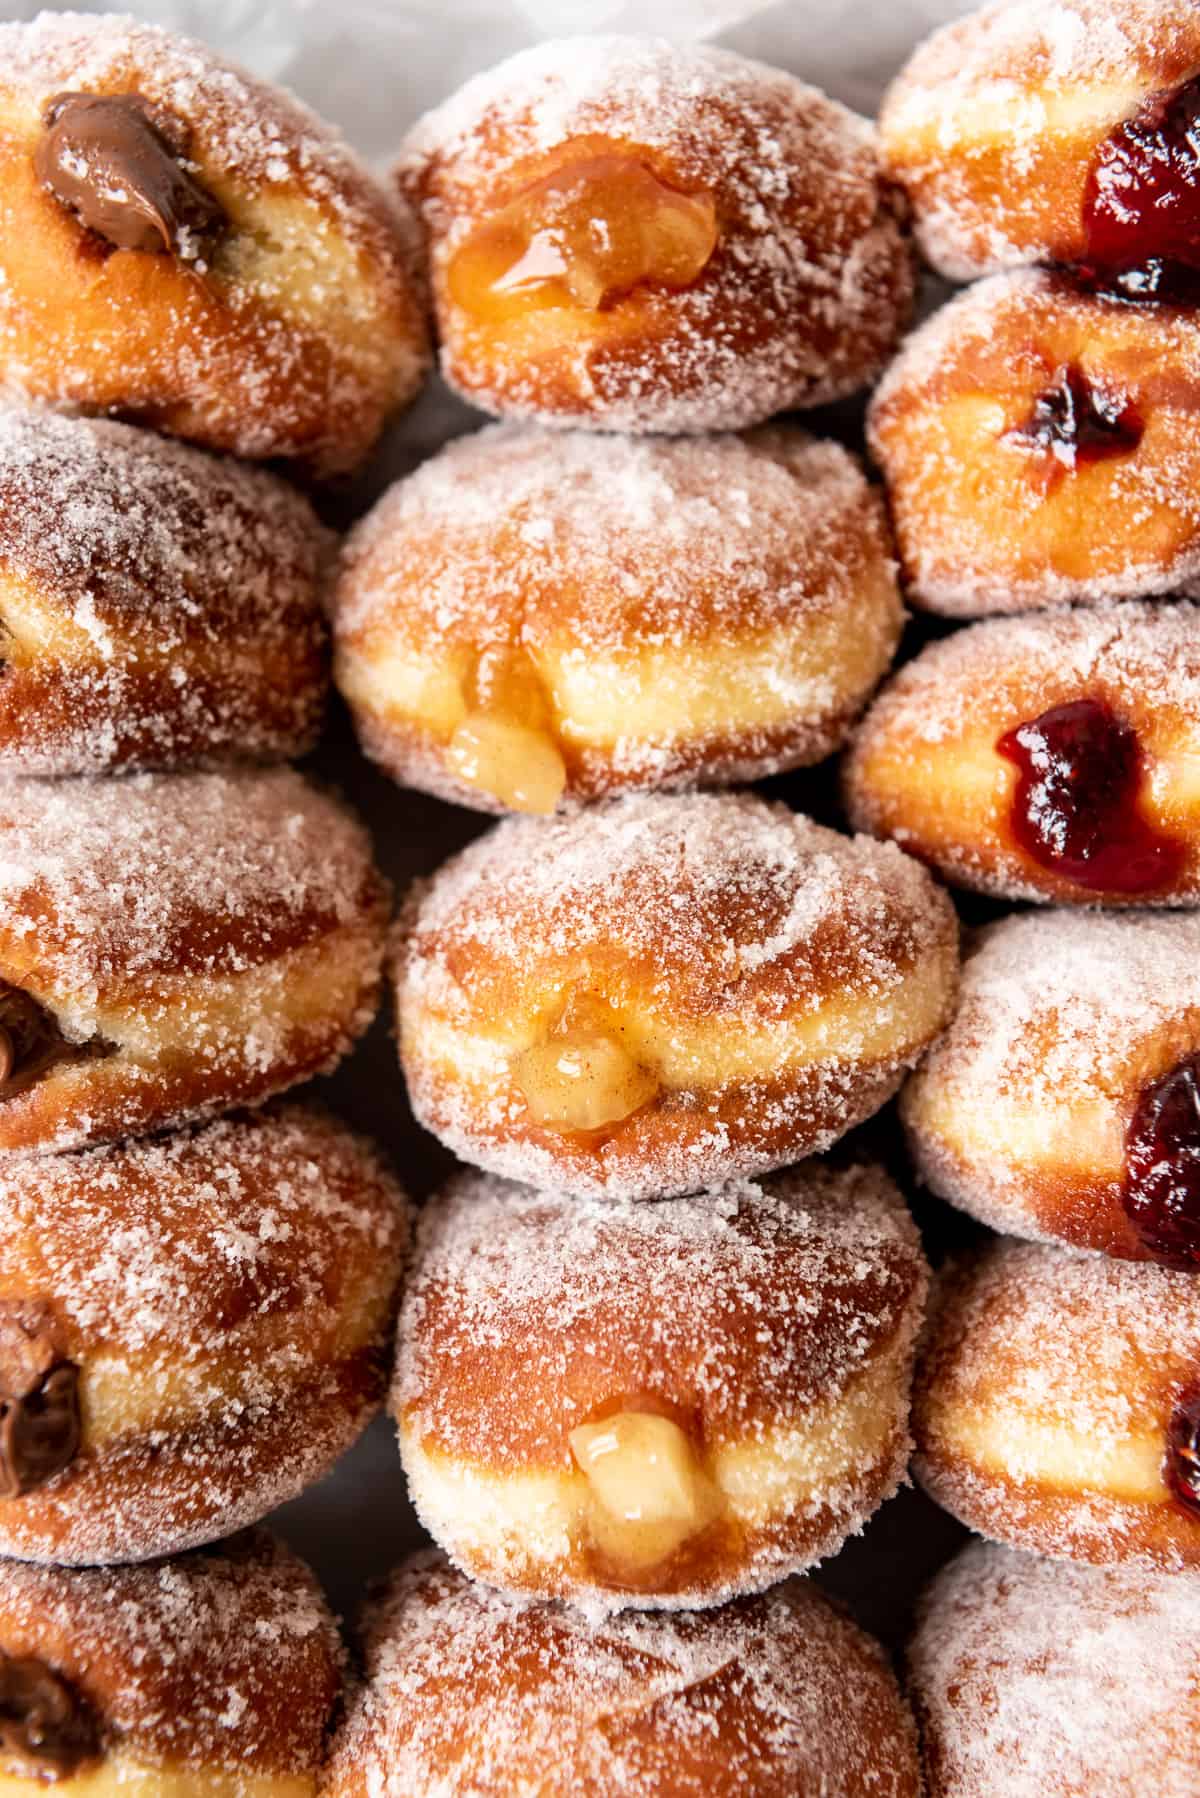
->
xmin=901 ymin=912 xmax=1200 ymax=1268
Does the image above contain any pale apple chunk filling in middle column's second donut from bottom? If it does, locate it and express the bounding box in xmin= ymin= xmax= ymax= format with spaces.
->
xmin=570 ymin=1411 xmax=718 ymax=1577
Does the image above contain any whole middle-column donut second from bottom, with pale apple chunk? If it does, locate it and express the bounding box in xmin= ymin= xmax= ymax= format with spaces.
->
xmin=390 ymin=1162 xmax=925 ymax=1611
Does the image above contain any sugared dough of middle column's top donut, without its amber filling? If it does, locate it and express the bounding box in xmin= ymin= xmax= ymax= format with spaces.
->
xmin=399 ymin=36 xmax=912 ymax=432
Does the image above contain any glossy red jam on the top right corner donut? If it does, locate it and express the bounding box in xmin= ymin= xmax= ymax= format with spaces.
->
xmin=1083 ymin=79 xmax=1200 ymax=298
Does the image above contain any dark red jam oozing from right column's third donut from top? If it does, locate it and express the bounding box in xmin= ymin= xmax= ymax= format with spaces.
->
xmin=997 ymin=699 xmax=1184 ymax=894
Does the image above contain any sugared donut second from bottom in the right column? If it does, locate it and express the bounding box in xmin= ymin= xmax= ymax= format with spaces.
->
xmin=912 ymin=1241 xmax=1200 ymax=1573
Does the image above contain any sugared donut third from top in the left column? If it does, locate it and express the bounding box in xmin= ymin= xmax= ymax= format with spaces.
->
xmin=0 ymin=770 xmax=387 ymax=1151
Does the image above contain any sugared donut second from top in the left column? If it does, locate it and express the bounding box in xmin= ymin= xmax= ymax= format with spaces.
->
xmin=0 ymin=408 xmax=329 ymax=775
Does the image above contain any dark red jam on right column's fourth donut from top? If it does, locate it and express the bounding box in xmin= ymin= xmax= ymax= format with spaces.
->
xmin=1121 ymin=1055 xmax=1200 ymax=1268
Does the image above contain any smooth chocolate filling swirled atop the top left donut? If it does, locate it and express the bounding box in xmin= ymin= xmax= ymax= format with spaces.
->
xmin=34 ymin=93 xmax=225 ymax=261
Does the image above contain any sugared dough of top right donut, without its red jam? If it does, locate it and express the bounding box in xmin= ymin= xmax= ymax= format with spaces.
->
xmin=880 ymin=0 xmax=1200 ymax=280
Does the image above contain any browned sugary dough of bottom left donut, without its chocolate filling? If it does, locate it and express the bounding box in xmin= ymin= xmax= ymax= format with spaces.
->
xmin=0 ymin=1530 xmax=342 ymax=1780
